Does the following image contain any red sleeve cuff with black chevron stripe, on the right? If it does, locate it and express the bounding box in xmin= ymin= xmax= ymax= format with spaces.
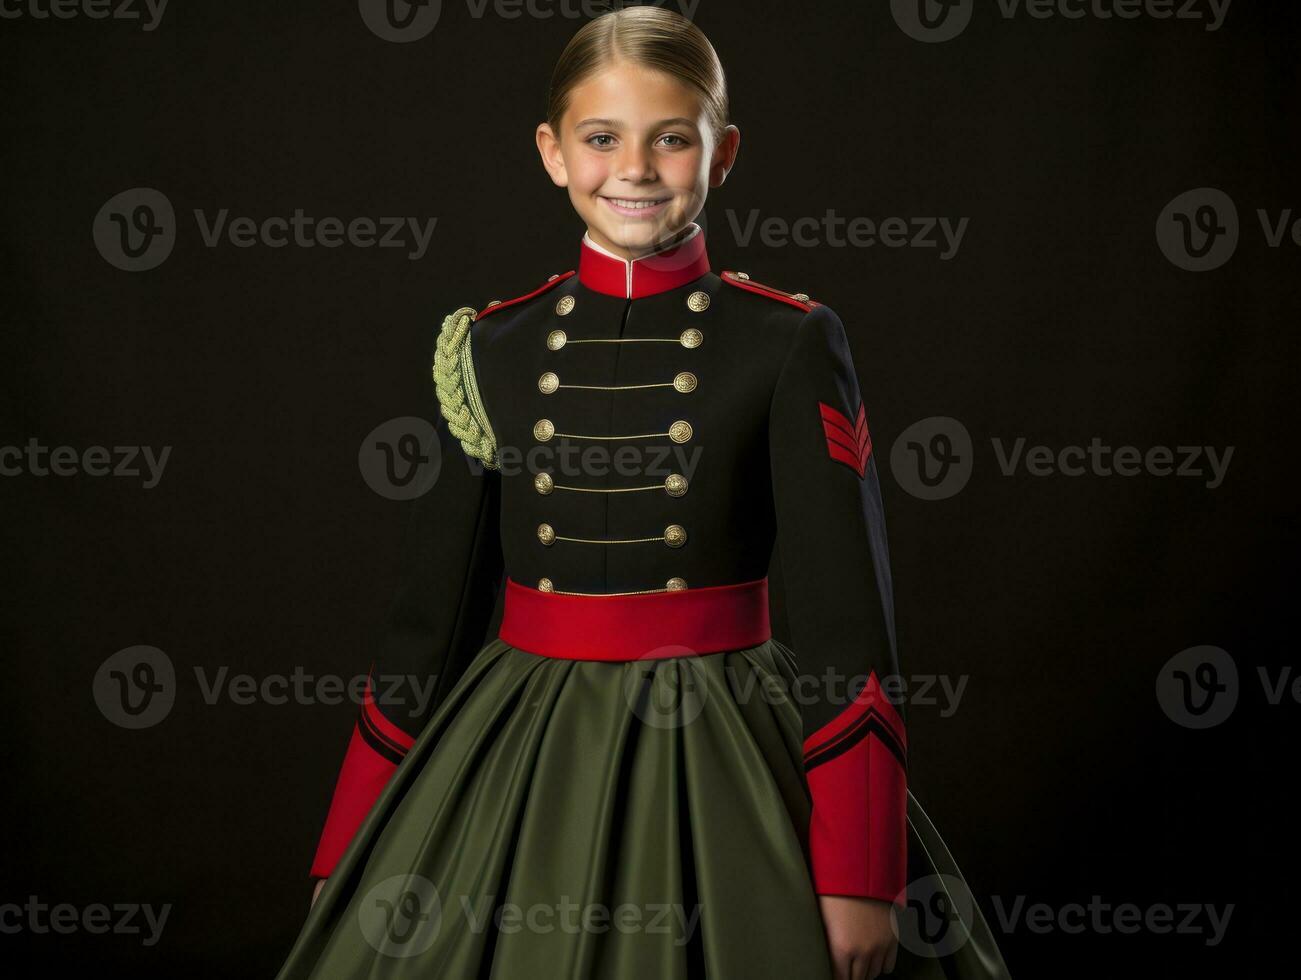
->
xmin=804 ymin=673 xmax=908 ymax=906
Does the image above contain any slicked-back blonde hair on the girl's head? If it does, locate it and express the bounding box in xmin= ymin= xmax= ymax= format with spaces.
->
xmin=546 ymin=7 xmax=729 ymax=141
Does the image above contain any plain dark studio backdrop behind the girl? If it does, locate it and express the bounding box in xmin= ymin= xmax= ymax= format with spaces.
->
xmin=0 ymin=0 xmax=1301 ymax=977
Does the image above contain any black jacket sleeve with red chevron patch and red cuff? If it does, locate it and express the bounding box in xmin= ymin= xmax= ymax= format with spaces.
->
xmin=769 ymin=305 xmax=907 ymax=901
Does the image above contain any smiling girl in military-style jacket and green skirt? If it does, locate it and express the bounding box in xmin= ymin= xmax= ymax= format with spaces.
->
xmin=280 ymin=7 xmax=1006 ymax=980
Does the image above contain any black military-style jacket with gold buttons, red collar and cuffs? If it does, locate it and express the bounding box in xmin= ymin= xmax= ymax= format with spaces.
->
xmin=311 ymin=225 xmax=907 ymax=901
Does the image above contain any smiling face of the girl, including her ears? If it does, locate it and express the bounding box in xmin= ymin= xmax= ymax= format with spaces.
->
xmin=537 ymin=61 xmax=740 ymax=259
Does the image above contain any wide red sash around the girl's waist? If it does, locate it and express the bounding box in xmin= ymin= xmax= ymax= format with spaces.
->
xmin=497 ymin=577 xmax=773 ymax=661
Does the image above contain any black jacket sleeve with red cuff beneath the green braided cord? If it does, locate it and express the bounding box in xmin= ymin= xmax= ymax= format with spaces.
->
xmin=311 ymin=310 xmax=502 ymax=877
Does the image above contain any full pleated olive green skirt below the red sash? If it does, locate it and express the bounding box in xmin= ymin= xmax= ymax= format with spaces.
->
xmin=278 ymin=639 xmax=1006 ymax=980
